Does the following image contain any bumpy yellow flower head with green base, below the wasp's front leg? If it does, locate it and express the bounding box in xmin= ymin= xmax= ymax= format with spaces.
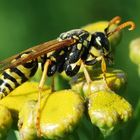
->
xmin=88 ymin=90 xmax=132 ymax=136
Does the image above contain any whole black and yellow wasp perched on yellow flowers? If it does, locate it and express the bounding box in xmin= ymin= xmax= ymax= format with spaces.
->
xmin=0 ymin=16 xmax=135 ymax=135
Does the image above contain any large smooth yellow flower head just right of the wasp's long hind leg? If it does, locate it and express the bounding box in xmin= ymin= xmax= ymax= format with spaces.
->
xmin=40 ymin=90 xmax=84 ymax=139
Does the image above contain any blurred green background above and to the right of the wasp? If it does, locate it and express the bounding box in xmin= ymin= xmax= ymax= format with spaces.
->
xmin=0 ymin=0 xmax=140 ymax=140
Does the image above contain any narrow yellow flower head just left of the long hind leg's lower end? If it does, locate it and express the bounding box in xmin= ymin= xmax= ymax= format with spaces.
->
xmin=18 ymin=100 xmax=37 ymax=140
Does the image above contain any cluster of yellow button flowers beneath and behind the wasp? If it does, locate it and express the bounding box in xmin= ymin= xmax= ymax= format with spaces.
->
xmin=0 ymin=21 xmax=133 ymax=140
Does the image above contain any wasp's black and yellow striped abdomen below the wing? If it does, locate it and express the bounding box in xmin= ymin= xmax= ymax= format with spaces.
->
xmin=0 ymin=51 xmax=38 ymax=99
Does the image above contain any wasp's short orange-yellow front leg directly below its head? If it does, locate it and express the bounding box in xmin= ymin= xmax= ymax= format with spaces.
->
xmin=101 ymin=57 xmax=110 ymax=89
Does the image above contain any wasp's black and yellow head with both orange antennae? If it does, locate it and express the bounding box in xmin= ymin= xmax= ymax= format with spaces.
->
xmin=90 ymin=16 xmax=135 ymax=62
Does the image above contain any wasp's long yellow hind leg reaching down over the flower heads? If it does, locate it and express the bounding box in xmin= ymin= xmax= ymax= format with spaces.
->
xmin=36 ymin=60 xmax=50 ymax=137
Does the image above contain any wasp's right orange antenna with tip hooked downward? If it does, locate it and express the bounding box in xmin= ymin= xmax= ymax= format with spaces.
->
xmin=107 ymin=21 xmax=135 ymax=37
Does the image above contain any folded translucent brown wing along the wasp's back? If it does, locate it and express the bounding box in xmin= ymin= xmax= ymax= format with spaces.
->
xmin=0 ymin=39 xmax=74 ymax=73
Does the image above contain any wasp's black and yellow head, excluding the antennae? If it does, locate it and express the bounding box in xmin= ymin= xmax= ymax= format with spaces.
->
xmin=90 ymin=32 xmax=110 ymax=57
